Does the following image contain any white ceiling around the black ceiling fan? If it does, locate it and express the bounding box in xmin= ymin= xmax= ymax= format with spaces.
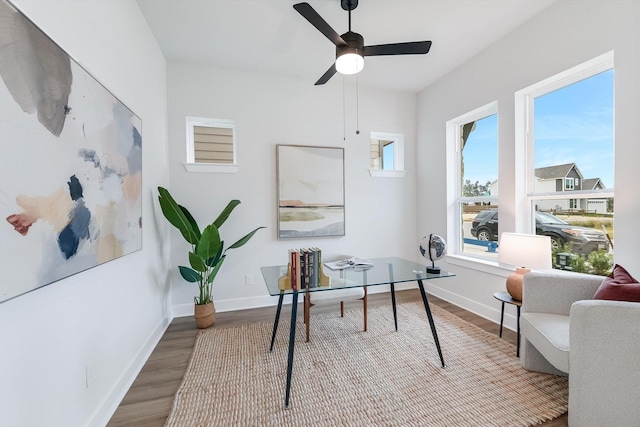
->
xmin=138 ymin=0 xmax=557 ymax=92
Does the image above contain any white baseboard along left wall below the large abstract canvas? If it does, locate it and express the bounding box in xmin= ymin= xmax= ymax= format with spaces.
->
xmin=88 ymin=312 xmax=172 ymax=426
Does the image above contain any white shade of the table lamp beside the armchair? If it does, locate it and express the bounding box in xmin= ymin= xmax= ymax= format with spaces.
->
xmin=498 ymin=233 xmax=551 ymax=269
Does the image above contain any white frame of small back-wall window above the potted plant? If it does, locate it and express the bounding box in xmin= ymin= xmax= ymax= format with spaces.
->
xmin=184 ymin=116 xmax=240 ymax=173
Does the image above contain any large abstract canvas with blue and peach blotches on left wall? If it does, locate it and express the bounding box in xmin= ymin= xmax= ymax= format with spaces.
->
xmin=0 ymin=0 xmax=142 ymax=302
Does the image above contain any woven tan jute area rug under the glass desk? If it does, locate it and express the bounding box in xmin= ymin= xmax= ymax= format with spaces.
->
xmin=166 ymin=302 xmax=568 ymax=427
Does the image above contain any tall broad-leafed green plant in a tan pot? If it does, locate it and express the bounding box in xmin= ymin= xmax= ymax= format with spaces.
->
xmin=158 ymin=187 xmax=265 ymax=328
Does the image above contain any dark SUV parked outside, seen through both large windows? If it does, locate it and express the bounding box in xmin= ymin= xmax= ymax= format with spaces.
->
xmin=471 ymin=209 xmax=609 ymax=255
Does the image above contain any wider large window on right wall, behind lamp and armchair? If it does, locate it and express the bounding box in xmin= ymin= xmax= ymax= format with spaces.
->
xmin=516 ymin=54 xmax=614 ymax=274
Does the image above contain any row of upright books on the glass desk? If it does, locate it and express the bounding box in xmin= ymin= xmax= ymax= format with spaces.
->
xmin=279 ymin=248 xmax=329 ymax=291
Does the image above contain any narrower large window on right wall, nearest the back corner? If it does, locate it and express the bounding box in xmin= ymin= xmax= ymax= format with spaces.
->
xmin=447 ymin=103 xmax=499 ymax=258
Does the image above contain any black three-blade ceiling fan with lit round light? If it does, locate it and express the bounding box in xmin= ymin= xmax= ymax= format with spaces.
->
xmin=293 ymin=0 xmax=431 ymax=85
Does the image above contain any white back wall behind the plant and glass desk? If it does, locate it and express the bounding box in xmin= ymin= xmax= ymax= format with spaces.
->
xmin=167 ymin=64 xmax=421 ymax=315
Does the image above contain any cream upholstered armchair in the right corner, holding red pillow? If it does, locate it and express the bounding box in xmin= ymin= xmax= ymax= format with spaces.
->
xmin=520 ymin=272 xmax=640 ymax=427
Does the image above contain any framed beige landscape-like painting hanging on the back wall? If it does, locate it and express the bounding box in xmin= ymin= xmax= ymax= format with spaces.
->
xmin=276 ymin=145 xmax=345 ymax=239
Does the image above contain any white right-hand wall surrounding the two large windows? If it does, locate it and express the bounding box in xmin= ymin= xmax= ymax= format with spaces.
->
xmin=417 ymin=0 xmax=640 ymax=327
